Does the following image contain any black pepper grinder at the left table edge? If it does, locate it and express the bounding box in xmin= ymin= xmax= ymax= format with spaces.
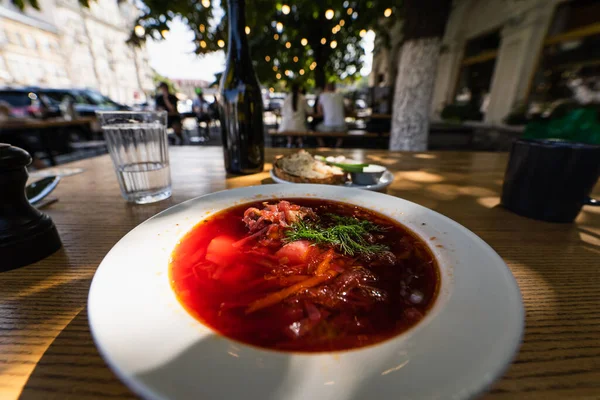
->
xmin=0 ymin=143 xmax=62 ymax=271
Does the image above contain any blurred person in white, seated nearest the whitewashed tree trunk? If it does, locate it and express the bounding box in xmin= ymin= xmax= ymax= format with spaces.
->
xmin=317 ymin=82 xmax=348 ymax=147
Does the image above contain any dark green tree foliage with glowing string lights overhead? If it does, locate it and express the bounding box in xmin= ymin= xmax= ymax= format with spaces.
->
xmin=12 ymin=0 xmax=401 ymax=86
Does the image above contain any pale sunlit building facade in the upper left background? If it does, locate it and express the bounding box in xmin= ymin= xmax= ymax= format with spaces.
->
xmin=0 ymin=0 xmax=154 ymax=104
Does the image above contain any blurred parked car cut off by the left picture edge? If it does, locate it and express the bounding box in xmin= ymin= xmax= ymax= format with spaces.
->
xmin=0 ymin=88 xmax=60 ymax=118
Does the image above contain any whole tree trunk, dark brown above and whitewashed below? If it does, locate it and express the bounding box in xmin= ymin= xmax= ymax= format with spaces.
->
xmin=390 ymin=0 xmax=452 ymax=151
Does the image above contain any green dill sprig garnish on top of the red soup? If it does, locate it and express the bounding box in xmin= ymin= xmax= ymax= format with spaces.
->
xmin=285 ymin=214 xmax=389 ymax=257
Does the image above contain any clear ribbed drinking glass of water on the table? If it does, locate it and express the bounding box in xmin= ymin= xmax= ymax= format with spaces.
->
xmin=96 ymin=111 xmax=171 ymax=204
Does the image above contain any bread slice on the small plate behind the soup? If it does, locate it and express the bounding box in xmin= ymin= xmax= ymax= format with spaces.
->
xmin=273 ymin=150 xmax=346 ymax=185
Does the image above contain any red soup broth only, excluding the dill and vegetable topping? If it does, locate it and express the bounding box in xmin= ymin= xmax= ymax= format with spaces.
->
xmin=170 ymin=198 xmax=440 ymax=352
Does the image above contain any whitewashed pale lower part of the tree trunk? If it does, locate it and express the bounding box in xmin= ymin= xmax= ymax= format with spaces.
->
xmin=390 ymin=38 xmax=441 ymax=151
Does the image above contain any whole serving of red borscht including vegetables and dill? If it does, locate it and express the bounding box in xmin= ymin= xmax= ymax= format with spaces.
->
xmin=170 ymin=198 xmax=440 ymax=352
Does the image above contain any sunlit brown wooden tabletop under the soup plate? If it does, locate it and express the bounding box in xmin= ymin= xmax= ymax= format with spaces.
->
xmin=0 ymin=147 xmax=600 ymax=400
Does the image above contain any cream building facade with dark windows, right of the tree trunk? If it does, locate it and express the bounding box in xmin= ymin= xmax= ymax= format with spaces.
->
xmin=372 ymin=0 xmax=600 ymax=123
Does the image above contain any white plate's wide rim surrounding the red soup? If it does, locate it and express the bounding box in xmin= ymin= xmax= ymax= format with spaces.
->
xmin=88 ymin=185 xmax=524 ymax=400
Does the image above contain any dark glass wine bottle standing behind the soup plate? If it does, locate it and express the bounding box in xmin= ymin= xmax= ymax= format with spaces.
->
xmin=219 ymin=0 xmax=265 ymax=174
